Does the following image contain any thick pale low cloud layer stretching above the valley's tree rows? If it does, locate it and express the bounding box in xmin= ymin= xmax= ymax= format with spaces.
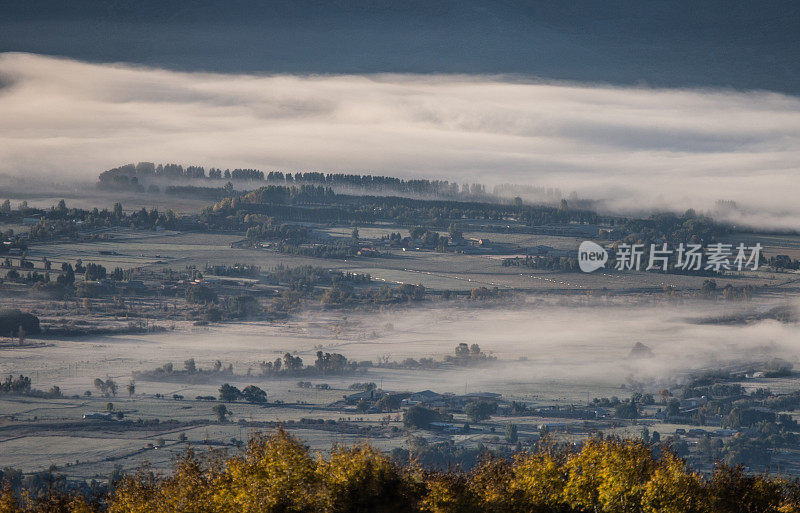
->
xmin=0 ymin=53 xmax=800 ymax=229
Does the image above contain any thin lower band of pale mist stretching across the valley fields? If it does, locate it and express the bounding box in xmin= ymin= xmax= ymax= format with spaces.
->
xmin=0 ymin=301 xmax=800 ymax=397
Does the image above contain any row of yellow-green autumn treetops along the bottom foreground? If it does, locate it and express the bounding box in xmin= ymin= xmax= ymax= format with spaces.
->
xmin=0 ymin=429 xmax=800 ymax=513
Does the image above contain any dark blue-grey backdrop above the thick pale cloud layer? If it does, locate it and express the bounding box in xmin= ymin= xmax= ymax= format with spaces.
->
xmin=0 ymin=0 xmax=800 ymax=94
